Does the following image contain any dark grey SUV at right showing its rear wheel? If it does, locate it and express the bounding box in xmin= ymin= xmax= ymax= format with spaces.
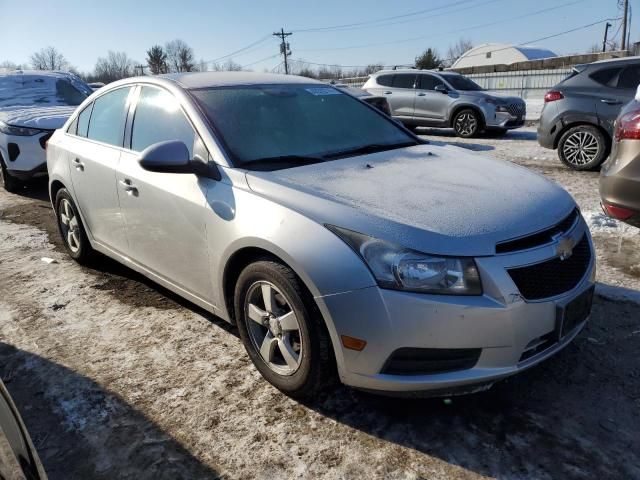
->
xmin=538 ymin=57 xmax=640 ymax=170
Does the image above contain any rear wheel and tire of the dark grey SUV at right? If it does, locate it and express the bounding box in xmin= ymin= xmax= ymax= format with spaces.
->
xmin=558 ymin=125 xmax=610 ymax=170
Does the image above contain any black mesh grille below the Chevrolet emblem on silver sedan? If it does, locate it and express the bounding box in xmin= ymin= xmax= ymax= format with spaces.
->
xmin=507 ymin=235 xmax=591 ymax=300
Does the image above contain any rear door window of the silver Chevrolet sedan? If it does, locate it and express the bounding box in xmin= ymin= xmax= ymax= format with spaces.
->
xmin=87 ymin=87 xmax=131 ymax=147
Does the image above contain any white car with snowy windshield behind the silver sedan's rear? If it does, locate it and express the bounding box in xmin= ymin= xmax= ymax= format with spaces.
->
xmin=0 ymin=70 xmax=93 ymax=192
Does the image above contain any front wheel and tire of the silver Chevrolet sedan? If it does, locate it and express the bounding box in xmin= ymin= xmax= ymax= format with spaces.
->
xmin=234 ymin=258 xmax=335 ymax=398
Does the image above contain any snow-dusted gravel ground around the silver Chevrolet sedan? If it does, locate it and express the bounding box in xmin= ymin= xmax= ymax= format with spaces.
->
xmin=0 ymin=128 xmax=640 ymax=480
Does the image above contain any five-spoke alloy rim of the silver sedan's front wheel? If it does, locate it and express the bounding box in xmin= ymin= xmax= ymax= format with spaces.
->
xmin=244 ymin=281 xmax=304 ymax=375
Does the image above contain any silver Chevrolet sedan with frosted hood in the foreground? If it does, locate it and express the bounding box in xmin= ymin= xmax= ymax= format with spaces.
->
xmin=47 ymin=72 xmax=595 ymax=396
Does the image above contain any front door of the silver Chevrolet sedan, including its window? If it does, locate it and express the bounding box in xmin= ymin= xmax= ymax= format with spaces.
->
xmin=116 ymin=85 xmax=217 ymax=299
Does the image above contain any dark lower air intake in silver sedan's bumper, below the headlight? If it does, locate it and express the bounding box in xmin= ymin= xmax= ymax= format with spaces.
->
xmin=382 ymin=348 xmax=482 ymax=375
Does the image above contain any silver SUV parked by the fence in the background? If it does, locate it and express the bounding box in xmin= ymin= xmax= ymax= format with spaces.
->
xmin=362 ymin=69 xmax=526 ymax=137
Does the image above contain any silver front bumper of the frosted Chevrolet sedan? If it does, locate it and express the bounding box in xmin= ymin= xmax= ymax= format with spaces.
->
xmin=317 ymin=222 xmax=595 ymax=395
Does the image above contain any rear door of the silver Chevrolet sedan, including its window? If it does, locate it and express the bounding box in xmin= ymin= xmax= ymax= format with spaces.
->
xmin=68 ymin=87 xmax=132 ymax=253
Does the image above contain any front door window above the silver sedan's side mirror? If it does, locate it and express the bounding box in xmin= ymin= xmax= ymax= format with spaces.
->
xmin=131 ymin=87 xmax=196 ymax=157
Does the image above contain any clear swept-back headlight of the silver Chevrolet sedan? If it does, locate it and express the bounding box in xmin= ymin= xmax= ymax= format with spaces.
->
xmin=327 ymin=225 xmax=482 ymax=295
